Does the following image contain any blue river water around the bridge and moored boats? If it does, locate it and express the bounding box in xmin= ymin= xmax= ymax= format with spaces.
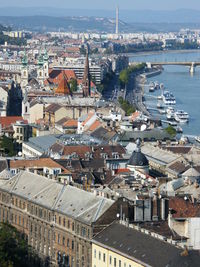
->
xmin=130 ymin=50 xmax=200 ymax=135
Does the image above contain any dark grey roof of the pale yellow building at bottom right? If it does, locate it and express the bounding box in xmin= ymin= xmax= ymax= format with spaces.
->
xmin=94 ymin=223 xmax=200 ymax=267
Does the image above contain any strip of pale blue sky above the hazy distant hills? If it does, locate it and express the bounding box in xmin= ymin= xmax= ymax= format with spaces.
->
xmin=0 ymin=0 xmax=200 ymax=10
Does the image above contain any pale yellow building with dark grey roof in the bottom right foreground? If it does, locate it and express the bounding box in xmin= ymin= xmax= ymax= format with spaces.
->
xmin=92 ymin=222 xmax=193 ymax=267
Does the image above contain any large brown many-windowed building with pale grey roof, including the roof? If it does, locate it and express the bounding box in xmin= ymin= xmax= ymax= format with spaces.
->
xmin=0 ymin=171 xmax=118 ymax=267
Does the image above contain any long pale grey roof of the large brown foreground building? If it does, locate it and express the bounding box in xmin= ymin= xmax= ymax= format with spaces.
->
xmin=0 ymin=171 xmax=114 ymax=224
